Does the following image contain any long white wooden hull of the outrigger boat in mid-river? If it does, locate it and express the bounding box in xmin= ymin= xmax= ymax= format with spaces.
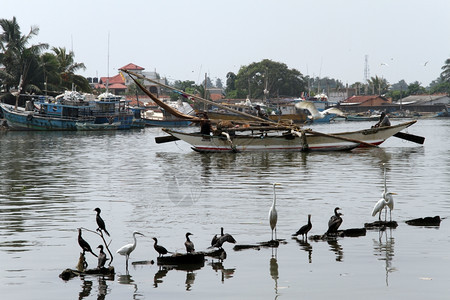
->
xmin=163 ymin=120 xmax=416 ymax=152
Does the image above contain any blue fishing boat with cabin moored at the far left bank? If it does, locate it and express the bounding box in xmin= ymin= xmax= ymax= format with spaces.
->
xmin=0 ymin=96 xmax=95 ymax=131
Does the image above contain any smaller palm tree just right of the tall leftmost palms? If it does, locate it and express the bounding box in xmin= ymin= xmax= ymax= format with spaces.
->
xmin=52 ymin=47 xmax=91 ymax=92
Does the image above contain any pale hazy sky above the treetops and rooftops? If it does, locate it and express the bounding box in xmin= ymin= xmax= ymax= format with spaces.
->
xmin=0 ymin=0 xmax=450 ymax=86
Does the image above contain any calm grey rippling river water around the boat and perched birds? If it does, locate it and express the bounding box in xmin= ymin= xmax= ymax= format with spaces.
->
xmin=0 ymin=119 xmax=450 ymax=299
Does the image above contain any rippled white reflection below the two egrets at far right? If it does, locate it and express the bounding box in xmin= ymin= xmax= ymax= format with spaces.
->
xmin=373 ymin=229 xmax=396 ymax=286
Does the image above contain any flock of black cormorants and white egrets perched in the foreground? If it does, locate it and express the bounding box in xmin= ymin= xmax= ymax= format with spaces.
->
xmin=78 ymin=163 xmax=396 ymax=270
